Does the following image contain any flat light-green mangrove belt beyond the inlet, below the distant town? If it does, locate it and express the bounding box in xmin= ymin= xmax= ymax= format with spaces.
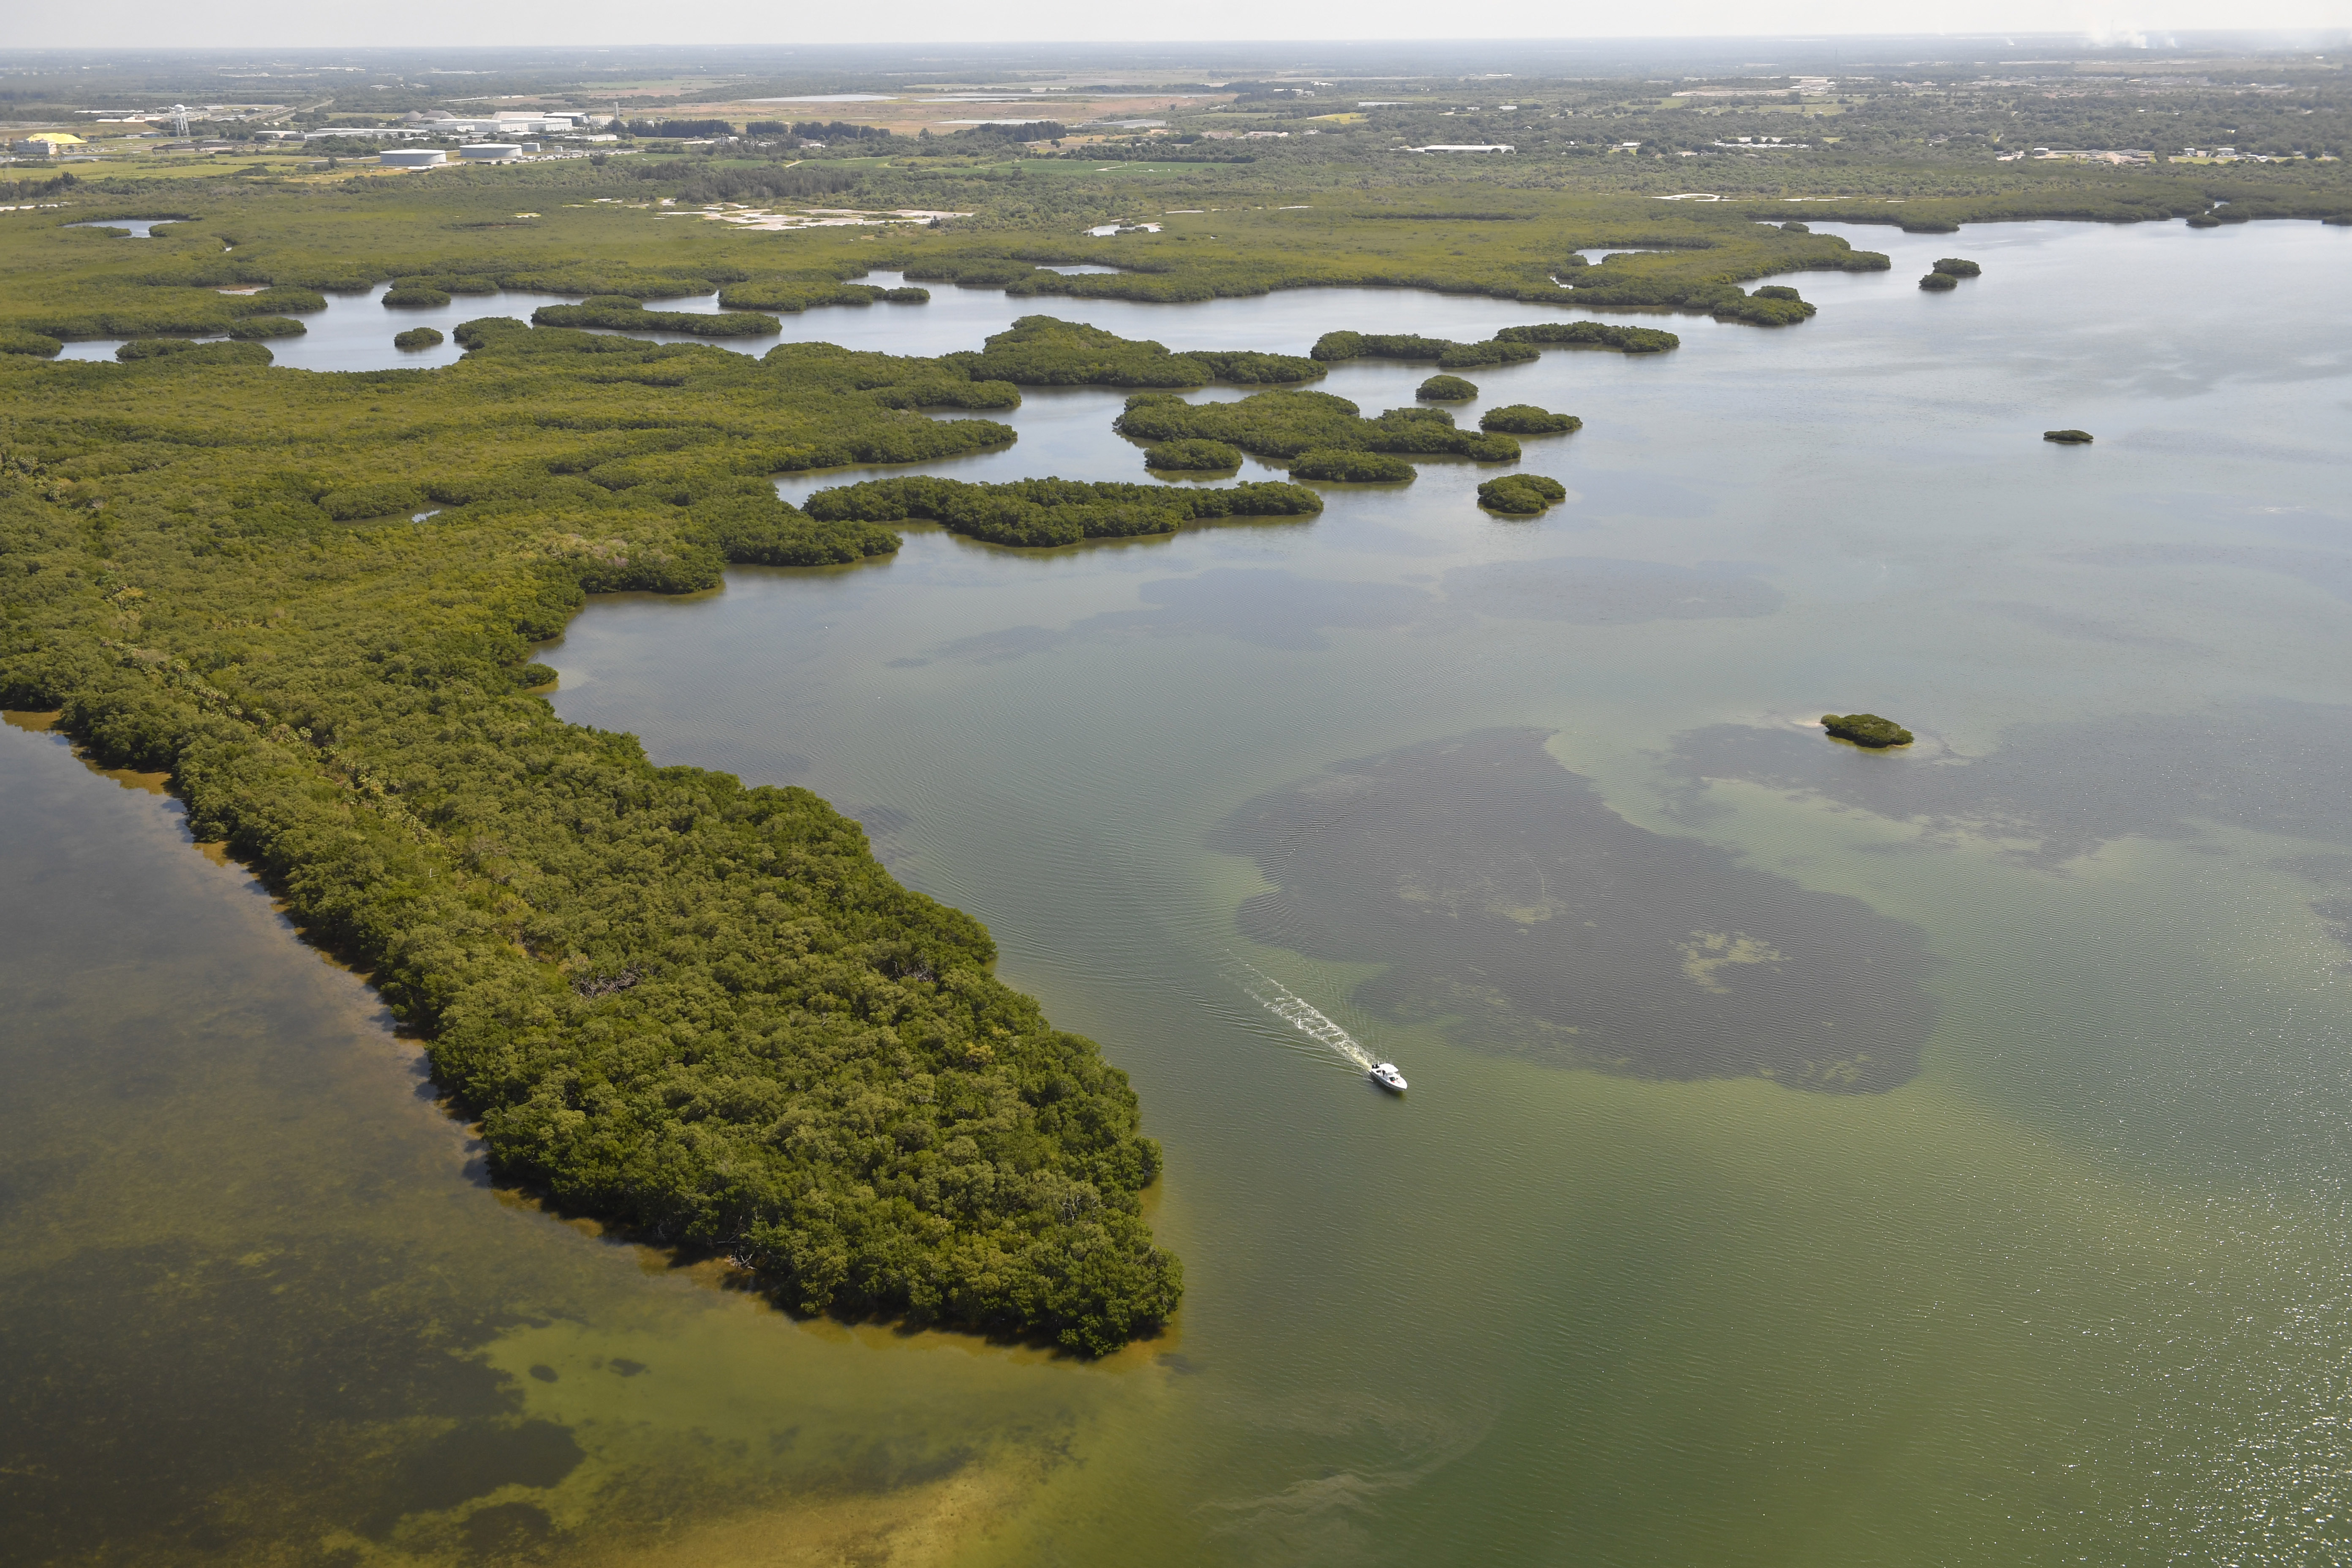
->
xmin=0 ymin=192 xmax=1957 ymax=355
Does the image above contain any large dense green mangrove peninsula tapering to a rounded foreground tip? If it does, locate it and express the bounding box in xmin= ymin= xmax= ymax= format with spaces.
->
xmin=0 ymin=320 xmax=1204 ymax=1352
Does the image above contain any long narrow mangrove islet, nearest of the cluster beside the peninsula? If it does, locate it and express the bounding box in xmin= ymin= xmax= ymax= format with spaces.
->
xmin=807 ymin=472 xmax=1322 ymax=550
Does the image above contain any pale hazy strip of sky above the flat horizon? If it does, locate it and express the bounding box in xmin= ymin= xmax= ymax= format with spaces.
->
xmin=0 ymin=0 xmax=2352 ymax=49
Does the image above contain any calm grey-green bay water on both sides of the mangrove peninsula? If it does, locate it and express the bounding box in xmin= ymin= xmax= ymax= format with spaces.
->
xmin=0 ymin=226 xmax=2352 ymax=1566
